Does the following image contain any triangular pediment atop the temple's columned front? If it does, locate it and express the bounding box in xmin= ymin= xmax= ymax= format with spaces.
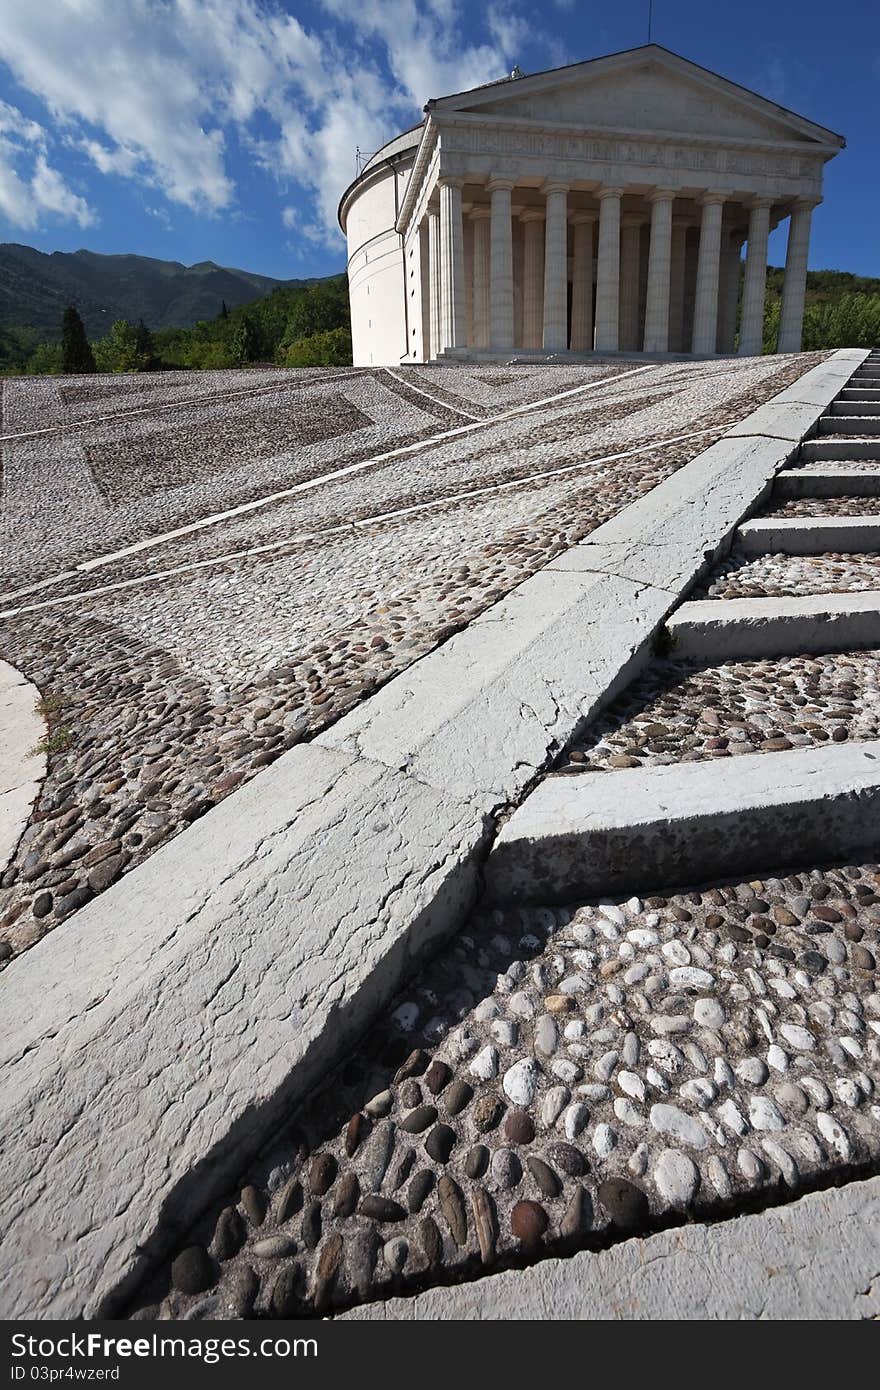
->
xmin=428 ymin=44 xmax=842 ymax=147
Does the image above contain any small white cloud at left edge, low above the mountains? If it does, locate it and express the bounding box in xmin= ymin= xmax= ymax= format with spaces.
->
xmin=0 ymin=101 xmax=96 ymax=229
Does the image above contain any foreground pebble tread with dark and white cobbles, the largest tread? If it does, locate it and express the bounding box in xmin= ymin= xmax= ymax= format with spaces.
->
xmin=135 ymin=865 xmax=880 ymax=1318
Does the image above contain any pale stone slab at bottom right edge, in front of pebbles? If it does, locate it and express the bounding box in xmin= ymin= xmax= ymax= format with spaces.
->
xmin=342 ymin=1177 xmax=880 ymax=1322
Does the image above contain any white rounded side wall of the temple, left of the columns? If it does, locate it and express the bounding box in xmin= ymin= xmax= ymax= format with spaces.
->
xmin=339 ymin=133 xmax=418 ymax=367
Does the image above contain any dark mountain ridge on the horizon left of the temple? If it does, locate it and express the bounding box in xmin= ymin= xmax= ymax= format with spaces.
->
xmin=0 ymin=242 xmax=316 ymax=338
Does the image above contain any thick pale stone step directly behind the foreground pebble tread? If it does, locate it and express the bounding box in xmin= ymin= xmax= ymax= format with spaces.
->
xmin=485 ymin=742 xmax=880 ymax=904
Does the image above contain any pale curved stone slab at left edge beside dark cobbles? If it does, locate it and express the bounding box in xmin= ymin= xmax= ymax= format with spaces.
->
xmin=0 ymin=662 xmax=46 ymax=872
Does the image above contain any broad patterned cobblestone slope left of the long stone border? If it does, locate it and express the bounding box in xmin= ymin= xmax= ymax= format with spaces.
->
xmin=0 ymin=354 xmax=817 ymax=959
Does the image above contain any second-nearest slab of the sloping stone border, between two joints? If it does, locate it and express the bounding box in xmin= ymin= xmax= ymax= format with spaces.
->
xmin=317 ymin=570 xmax=674 ymax=810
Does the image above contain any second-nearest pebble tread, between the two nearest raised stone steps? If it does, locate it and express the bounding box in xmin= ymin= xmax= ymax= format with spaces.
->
xmin=559 ymin=652 xmax=880 ymax=773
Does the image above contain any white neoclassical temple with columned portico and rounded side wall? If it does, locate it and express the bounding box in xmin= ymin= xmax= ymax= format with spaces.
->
xmin=339 ymin=44 xmax=845 ymax=366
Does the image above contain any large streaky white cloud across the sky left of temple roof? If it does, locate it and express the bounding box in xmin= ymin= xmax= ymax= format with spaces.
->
xmin=0 ymin=0 xmax=546 ymax=240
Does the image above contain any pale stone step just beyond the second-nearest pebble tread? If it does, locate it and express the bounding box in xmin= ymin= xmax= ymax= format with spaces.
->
xmin=666 ymin=591 xmax=880 ymax=662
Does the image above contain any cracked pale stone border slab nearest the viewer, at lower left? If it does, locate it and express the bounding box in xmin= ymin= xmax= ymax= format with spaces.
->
xmin=0 ymin=746 xmax=484 ymax=1318
